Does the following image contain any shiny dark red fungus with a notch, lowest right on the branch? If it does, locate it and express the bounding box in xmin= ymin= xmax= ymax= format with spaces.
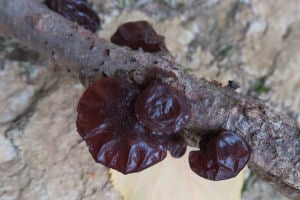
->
xmin=189 ymin=131 xmax=250 ymax=181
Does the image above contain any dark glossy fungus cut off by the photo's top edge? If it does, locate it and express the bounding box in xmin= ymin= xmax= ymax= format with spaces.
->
xmin=46 ymin=0 xmax=100 ymax=32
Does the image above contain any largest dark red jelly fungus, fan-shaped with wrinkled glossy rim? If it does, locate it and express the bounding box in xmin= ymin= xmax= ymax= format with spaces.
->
xmin=76 ymin=78 xmax=167 ymax=174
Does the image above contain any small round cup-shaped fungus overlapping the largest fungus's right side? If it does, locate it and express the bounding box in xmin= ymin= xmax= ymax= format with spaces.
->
xmin=135 ymin=82 xmax=190 ymax=135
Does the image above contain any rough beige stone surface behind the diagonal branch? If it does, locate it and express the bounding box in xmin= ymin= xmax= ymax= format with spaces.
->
xmin=0 ymin=0 xmax=300 ymax=200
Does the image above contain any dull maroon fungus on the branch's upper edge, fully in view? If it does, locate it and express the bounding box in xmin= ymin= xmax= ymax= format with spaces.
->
xmin=110 ymin=21 xmax=167 ymax=52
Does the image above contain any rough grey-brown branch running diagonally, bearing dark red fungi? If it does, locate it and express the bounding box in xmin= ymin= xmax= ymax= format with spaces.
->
xmin=0 ymin=0 xmax=300 ymax=199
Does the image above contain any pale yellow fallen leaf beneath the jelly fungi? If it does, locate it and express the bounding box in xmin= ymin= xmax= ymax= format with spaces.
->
xmin=110 ymin=147 xmax=244 ymax=200
